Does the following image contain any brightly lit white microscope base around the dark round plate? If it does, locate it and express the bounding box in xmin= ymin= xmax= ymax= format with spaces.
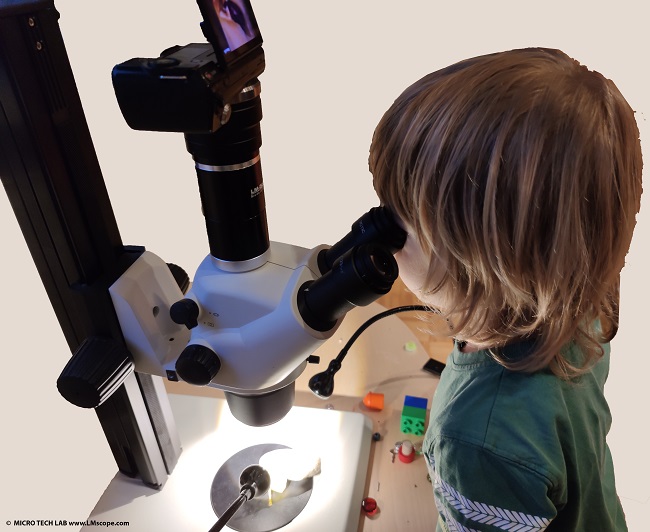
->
xmin=82 ymin=394 xmax=372 ymax=532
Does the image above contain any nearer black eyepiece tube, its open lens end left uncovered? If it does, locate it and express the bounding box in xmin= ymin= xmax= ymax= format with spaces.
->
xmin=298 ymin=244 xmax=398 ymax=331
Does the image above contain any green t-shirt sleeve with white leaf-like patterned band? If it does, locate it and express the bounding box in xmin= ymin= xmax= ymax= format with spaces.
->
xmin=426 ymin=438 xmax=557 ymax=532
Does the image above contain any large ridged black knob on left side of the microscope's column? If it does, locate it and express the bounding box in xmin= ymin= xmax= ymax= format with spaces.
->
xmin=56 ymin=336 xmax=135 ymax=408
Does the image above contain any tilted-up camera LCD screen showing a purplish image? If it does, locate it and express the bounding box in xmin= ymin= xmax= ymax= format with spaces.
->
xmin=197 ymin=0 xmax=262 ymax=66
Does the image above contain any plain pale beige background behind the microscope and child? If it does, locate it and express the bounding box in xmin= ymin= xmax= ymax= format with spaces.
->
xmin=0 ymin=0 xmax=650 ymax=530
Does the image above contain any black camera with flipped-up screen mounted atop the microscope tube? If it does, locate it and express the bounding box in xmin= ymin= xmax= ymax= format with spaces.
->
xmin=112 ymin=0 xmax=265 ymax=133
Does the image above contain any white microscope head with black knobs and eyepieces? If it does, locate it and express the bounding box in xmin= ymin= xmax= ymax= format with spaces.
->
xmin=166 ymin=214 xmax=401 ymax=426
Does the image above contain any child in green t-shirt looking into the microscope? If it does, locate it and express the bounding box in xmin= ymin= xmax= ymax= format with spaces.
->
xmin=369 ymin=49 xmax=642 ymax=532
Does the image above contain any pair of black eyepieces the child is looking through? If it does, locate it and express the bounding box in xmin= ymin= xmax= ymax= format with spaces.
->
xmin=298 ymin=207 xmax=406 ymax=331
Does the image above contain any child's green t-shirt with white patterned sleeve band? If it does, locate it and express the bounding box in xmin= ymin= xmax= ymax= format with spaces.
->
xmin=423 ymin=343 xmax=627 ymax=532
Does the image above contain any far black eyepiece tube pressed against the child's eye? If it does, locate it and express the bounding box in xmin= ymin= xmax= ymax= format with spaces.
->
xmin=318 ymin=207 xmax=406 ymax=274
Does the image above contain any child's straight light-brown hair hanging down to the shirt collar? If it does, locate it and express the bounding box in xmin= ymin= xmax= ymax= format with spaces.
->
xmin=369 ymin=48 xmax=642 ymax=378
